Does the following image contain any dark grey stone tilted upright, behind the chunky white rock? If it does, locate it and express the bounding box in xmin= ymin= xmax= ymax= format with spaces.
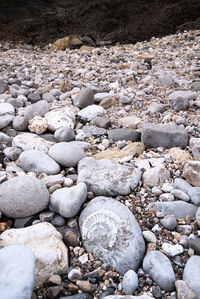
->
xmin=73 ymin=88 xmax=94 ymax=108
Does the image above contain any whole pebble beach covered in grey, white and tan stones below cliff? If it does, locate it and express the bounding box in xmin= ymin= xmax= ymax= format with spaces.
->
xmin=0 ymin=30 xmax=200 ymax=299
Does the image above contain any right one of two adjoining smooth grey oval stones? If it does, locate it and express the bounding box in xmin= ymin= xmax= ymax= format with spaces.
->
xmin=48 ymin=142 xmax=85 ymax=167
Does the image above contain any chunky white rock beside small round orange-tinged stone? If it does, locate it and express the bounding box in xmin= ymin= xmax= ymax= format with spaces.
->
xmin=45 ymin=107 xmax=75 ymax=132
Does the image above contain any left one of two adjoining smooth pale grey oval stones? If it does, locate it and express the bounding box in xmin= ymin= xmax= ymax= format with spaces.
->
xmin=18 ymin=150 xmax=60 ymax=175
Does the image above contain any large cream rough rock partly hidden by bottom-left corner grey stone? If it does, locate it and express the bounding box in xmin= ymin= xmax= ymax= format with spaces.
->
xmin=0 ymin=222 xmax=68 ymax=287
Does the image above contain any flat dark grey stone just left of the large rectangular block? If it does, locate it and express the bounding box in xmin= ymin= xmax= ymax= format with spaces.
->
xmin=108 ymin=128 xmax=140 ymax=142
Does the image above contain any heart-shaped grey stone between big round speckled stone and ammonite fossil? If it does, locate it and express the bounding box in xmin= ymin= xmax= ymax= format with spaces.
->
xmin=50 ymin=183 xmax=87 ymax=218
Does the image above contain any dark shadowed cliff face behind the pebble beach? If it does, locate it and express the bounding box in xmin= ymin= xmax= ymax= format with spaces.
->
xmin=0 ymin=0 xmax=200 ymax=43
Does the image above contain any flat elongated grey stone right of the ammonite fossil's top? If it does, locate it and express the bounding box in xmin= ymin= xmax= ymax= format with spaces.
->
xmin=148 ymin=200 xmax=197 ymax=218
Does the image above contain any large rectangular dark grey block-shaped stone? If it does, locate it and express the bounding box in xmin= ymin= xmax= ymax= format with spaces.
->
xmin=141 ymin=123 xmax=188 ymax=148
